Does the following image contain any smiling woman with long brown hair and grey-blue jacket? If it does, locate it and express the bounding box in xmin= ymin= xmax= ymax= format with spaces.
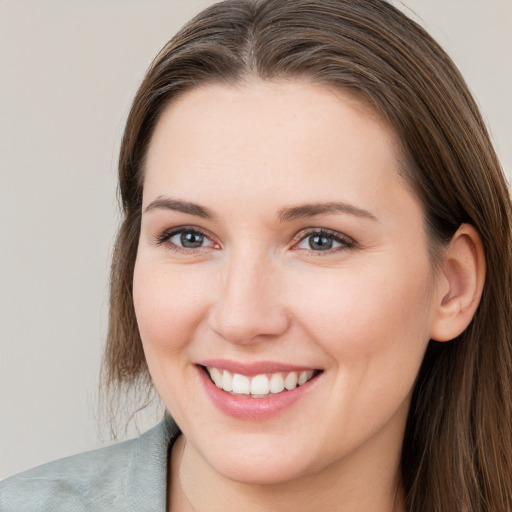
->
xmin=0 ymin=0 xmax=512 ymax=512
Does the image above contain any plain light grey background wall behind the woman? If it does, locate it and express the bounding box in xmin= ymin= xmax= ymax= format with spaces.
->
xmin=0 ymin=0 xmax=512 ymax=479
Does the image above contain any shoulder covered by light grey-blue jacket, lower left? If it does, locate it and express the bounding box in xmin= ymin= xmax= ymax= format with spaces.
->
xmin=0 ymin=419 xmax=179 ymax=512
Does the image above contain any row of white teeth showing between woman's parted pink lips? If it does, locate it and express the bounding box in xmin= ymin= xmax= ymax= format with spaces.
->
xmin=200 ymin=365 xmax=322 ymax=398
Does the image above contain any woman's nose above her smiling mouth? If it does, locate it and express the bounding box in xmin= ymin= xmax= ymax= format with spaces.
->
xmin=209 ymin=249 xmax=290 ymax=344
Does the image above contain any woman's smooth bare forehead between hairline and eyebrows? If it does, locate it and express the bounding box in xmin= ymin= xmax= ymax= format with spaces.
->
xmin=144 ymin=80 xmax=410 ymax=214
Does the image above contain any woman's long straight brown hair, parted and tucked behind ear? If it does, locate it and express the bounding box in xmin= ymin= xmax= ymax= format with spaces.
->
xmin=104 ymin=0 xmax=512 ymax=512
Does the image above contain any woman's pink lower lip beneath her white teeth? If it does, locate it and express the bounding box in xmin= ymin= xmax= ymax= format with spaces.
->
xmin=196 ymin=366 xmax=320 ymax=421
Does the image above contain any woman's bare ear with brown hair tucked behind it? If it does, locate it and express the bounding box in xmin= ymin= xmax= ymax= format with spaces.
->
xmin=430 ymin=224 xmax=485 ymax=341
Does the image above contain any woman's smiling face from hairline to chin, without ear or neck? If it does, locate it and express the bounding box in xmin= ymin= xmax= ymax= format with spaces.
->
xmin=134 ymin=81 xmax=438 ymax=483
